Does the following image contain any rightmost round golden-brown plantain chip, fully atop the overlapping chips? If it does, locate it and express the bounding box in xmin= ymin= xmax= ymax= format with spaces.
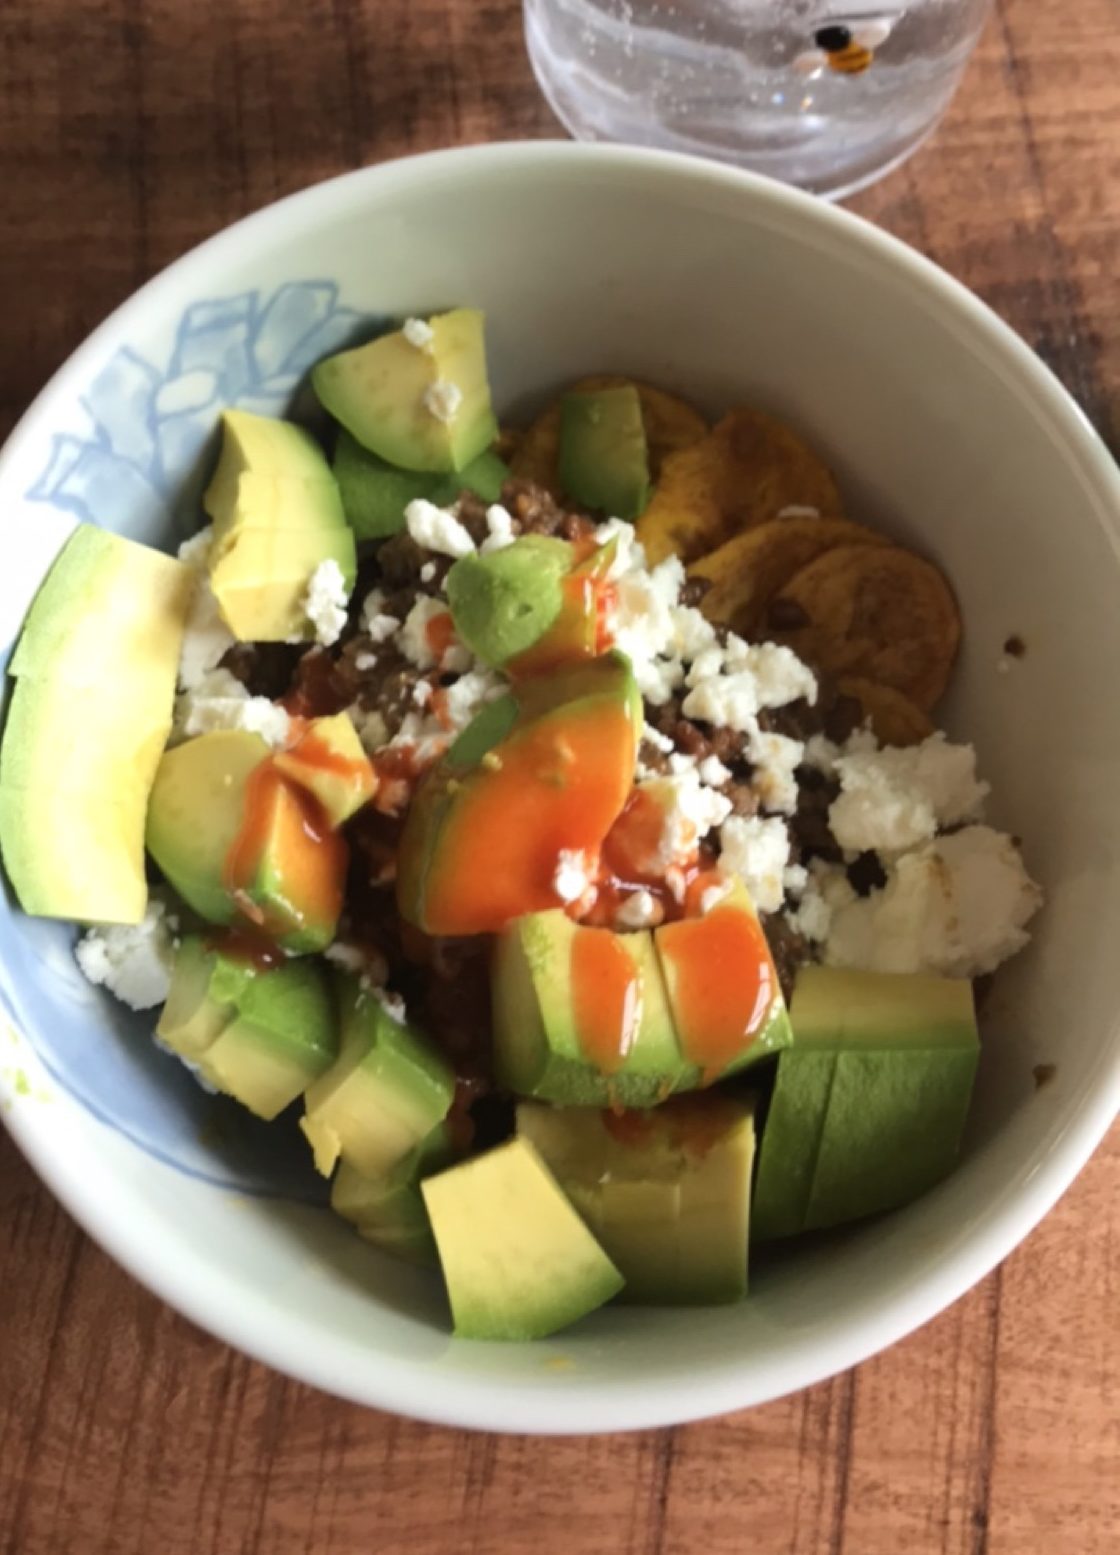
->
xmin=768 ymin=544 xmax=960 ymax=712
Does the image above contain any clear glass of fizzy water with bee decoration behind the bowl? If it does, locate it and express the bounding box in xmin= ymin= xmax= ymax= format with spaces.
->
xmin=524 ymin=0 xmax=989 ymax=197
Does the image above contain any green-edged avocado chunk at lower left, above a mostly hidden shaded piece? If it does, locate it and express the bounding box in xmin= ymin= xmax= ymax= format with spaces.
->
xmin=300 ymin=978 xmax=454 ymax=1177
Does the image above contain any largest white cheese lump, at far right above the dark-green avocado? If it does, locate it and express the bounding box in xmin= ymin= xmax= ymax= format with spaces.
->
xmin=824 ymin=826 xmax=1042 ymax=977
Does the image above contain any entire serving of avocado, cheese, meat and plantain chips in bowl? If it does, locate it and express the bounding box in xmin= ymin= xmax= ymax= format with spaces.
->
xmin=0 ymin=309 xmax=1041 ymax=1339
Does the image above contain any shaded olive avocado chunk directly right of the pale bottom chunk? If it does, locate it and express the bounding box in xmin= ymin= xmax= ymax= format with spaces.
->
xmin=518 ymin=1095 xmax=754 ymax=1306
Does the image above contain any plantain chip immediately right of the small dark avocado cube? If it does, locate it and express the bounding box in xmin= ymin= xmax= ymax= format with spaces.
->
xmin=638 ymin=409 xmax=843 ymax=563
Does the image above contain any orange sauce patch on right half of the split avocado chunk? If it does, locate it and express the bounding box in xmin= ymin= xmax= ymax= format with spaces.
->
xmin=658 ymin=907 xmax=776 ymax=1082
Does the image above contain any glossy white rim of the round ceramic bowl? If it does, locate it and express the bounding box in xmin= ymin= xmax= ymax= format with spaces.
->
xmin=0 ymin=140 xmax=1120 ymax=1434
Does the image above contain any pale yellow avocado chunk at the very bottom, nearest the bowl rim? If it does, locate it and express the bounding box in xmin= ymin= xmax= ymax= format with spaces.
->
xmin=422 ymin=1138 xmax=622 ymax=1340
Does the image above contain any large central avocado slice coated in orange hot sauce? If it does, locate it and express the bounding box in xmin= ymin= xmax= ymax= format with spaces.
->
xmin=397 ymin=653 xmax=642 ymax=935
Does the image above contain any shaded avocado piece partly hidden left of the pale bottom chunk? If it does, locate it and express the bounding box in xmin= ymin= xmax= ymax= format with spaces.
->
xmin=331 ymin=1123 xmax=457 ymax=1264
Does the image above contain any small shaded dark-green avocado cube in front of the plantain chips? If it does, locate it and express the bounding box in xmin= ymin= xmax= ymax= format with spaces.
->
xmin=560 ymin=384 xmax=650 ymax=519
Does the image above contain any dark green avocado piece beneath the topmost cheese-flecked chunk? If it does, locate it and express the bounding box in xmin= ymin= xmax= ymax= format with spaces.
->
xmin=334 ymin=428 xmax=510 ymax=540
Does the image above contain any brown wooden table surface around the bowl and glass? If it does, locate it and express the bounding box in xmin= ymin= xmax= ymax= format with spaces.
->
xmin=0 ymin=0 xmax=1120 ymax=1555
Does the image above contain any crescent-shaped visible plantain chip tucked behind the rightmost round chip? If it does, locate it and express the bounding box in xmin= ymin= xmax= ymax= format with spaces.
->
xmin=688 ymin=518 xmax=890 ymax=638
